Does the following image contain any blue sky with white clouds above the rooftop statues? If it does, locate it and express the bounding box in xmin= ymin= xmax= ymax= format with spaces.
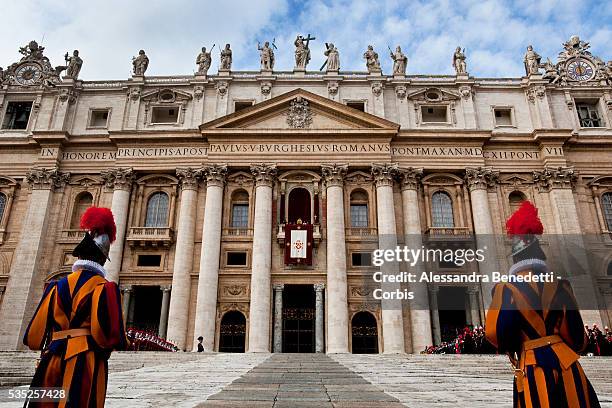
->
xmin=0 ymin=0 xmax=612 ymax=80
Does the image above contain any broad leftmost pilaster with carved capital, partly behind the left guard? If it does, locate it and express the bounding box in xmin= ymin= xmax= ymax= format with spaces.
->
xmin=0 ymin=168 xmax=70 ymax=350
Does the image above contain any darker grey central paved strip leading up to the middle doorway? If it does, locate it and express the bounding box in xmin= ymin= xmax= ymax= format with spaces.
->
xmin=199 ymin=354 xmax=403 ymax=408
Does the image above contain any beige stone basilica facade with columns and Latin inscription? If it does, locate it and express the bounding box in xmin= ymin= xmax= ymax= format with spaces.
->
xmin=0 ymin=36 xmax=612 ymax=353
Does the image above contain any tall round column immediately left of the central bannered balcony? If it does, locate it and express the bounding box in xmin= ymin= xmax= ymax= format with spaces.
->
xmin=248 ymin=164 xmax=276 ymax=353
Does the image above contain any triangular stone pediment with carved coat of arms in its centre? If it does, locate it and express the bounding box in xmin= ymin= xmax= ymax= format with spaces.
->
xmin=200 ymin=88 xmax=399 ymax=134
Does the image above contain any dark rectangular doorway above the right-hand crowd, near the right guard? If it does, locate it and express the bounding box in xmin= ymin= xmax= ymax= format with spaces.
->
xmin=438 ymin=286 xmax=467 ymax=341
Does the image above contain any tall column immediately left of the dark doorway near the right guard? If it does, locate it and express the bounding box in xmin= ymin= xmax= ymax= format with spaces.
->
xmin=400 ymin=168 xmax=433 ymax=353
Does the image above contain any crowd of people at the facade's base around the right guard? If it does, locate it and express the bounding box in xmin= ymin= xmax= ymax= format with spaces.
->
xmin=422 ymin=324 xmax=612 ymax=356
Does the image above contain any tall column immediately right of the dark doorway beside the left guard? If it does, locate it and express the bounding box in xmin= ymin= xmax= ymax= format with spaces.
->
xmin=165 ymin=168 xmax=202 ymax=350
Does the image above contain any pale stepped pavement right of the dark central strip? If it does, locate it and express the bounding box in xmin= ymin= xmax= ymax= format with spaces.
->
xmin=331 ymin=354 xmax=612 ymax=408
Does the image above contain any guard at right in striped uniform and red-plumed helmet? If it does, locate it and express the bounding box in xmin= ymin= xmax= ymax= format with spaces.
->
xmin=486 ymin=201 xmax=600 ymax=408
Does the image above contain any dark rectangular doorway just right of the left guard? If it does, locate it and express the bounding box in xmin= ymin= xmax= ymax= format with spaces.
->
xmin=128 ymin=286 xmax=162 ymax=334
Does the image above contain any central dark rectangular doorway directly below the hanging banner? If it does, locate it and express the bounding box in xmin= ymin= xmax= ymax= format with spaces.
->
xmin=282 ymin=285 xmax=315 ymax=353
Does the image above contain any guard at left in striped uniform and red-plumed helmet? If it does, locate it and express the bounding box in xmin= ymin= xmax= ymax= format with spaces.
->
xmin=23 ymin=207 xmax=128 ymax=407
